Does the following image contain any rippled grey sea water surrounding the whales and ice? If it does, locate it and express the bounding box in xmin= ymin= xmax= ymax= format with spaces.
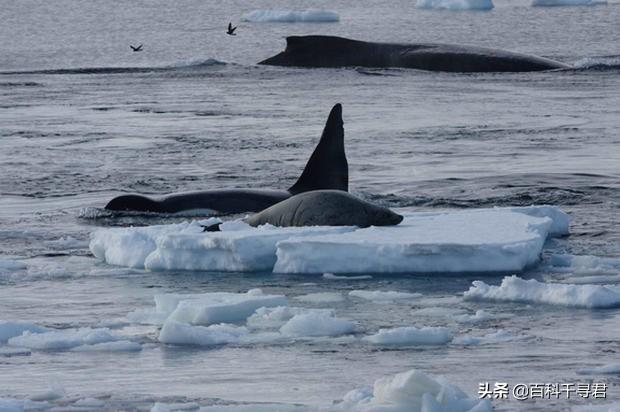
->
xmin=0 ymin=0 xmax=620 ymax=411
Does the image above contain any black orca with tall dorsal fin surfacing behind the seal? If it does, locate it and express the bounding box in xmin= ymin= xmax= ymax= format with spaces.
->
xmin=105 ymin=104 xmax=349 ymax=214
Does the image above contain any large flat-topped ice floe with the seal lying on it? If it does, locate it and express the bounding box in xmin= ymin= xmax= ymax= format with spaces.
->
xmin=90 ymin=206 xmax=569 ymax=274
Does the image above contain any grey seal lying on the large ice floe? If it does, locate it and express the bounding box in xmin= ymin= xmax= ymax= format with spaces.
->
xmin=244 ymin=190 xmax=403 ymax=227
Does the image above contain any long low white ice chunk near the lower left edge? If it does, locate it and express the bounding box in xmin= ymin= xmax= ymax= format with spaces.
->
xmin=8 ymin=328 xmax=122 ymax=350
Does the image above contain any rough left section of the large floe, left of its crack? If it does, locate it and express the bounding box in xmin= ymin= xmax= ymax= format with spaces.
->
xmin=90 ymin=220 xmax=354 ymax=272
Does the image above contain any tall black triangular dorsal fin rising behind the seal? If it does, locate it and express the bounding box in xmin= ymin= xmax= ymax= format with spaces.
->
xmin=288 ymin=103 xmax=349 ymax=195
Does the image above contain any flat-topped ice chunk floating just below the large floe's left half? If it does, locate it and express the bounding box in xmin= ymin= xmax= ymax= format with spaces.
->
xmin=155 ymin=289 xmax=288 ymax=326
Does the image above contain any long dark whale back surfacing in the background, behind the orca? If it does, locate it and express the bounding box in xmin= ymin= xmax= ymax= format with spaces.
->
xmin=259 ymin=36 xmax=570 ymax=73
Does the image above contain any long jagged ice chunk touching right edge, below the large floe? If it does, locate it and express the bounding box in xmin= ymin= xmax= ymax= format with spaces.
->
xmin=464 ymin=276 xmax=620 ymax=308
